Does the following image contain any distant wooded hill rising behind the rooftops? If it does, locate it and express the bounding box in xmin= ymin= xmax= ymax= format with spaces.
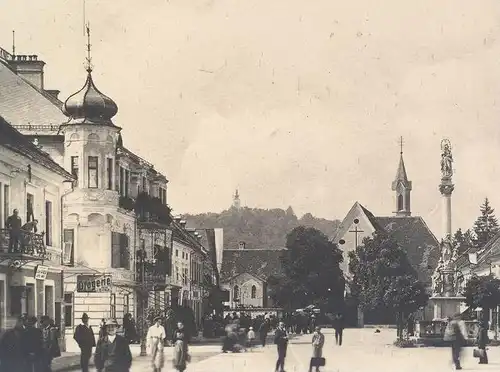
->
xmin=183 ymin=207 xmax=340 ymax=249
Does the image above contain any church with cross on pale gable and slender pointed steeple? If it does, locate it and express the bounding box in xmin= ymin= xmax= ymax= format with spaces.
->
xmin=333 ymin=149 xmax=440 ymax=324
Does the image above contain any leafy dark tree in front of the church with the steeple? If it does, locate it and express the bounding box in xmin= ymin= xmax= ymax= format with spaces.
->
xmin=349 ymin=232 xmax=428 ymax=335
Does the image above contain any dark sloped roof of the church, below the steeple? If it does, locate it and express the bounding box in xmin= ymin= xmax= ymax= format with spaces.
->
xmin=375 ymin=216 xmax=440 ymax=282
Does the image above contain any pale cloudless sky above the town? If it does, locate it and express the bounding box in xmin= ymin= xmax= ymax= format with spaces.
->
xmin=0 ymin=0 xmax=500 ymax=236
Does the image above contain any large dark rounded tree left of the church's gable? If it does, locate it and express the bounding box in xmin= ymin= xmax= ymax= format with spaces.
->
xmin=268 ymin=226 xmax=345 ymax=310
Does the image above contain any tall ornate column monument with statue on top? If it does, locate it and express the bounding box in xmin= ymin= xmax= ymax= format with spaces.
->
xmin=431 ymin=139 xmax=464 ymax=320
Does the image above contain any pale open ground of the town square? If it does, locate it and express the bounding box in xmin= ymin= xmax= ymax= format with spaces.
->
xmin=118 ymin=329 xmax=500 ymax=372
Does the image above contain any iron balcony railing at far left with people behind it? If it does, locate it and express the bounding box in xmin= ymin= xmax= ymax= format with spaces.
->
xmin=0 ymin=229 xmax=47 ymax=260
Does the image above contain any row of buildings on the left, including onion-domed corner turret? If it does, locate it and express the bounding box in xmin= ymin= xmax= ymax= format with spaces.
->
xmin=0 ymin=45 xmax=218 ymax=348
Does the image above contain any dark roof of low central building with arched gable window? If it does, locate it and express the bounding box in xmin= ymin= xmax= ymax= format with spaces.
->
xmin=221 ymin=249 xmax=288 ymax=281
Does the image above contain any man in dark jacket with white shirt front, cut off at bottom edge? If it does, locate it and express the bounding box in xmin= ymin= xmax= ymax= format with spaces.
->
xmin=94 ymin=319 xmax=132 ymax=372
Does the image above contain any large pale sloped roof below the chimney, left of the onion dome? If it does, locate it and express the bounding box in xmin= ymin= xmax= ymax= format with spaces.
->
xmin=0 ymin=60 xmax=68 ymax=126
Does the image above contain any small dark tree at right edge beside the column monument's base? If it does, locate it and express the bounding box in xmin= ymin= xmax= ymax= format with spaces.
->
xmin=462 ymin=275 xmax=500 ymax=320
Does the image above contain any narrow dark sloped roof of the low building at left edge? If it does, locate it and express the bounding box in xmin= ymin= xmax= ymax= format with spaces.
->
xmin=0 ymin=116 xmax=73 ymax=180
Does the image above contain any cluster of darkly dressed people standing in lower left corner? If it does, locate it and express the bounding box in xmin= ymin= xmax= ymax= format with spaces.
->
xmin=0 ymin=315 xmax=61 ymax=372
